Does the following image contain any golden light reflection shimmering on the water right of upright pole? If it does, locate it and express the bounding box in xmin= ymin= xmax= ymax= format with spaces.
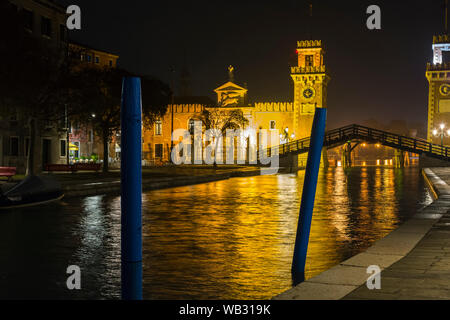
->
xmin=143 ymin=167 xmax=432 ymax=299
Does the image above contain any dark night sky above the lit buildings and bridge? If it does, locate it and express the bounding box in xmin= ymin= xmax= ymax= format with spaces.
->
xmin=58 ymin=0 xmax=444 ymax=129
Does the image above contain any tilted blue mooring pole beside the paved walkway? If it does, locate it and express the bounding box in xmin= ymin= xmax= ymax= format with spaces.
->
xmin=292 ymin=108 xmax=327 ymax=285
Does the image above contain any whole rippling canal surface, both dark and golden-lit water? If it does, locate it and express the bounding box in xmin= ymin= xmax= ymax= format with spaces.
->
xmin=0 ymin=167 xmax=431 ymax=299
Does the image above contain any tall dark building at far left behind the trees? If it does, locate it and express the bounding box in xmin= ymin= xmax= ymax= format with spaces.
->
xmin=0 ymin=0 xmax=67 ymax=173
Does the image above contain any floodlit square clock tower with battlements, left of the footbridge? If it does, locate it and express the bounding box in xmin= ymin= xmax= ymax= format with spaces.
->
xmin=291 ymin=40 xmax=330 ymax=166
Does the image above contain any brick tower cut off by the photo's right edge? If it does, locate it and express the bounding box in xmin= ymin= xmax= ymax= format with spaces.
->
xmin=425 ymin=34 xmax=450 ymax=145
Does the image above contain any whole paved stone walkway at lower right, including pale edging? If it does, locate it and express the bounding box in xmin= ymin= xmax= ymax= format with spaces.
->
xmin=274 ymin=168 xmax=450 ymax=300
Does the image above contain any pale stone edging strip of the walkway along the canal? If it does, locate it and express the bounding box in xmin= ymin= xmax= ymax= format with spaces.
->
xmin=273 ymin=168 xmax=450 ymax=300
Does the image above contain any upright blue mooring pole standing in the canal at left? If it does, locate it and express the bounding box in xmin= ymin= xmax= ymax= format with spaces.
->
xmin=120 ymin=77 xmax=142 ymax=300
